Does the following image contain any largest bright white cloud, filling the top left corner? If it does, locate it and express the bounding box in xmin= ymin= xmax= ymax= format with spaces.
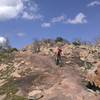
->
xmin=0 ymin=0 xmax=23 ymax=20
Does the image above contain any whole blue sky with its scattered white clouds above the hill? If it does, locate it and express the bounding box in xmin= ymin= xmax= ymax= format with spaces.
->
xmin=0 ymin=0 xmax=100 ymax=48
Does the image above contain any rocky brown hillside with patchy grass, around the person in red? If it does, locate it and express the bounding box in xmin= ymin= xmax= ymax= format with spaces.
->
xmin=0 ymin=41 xmax=100 ymax=100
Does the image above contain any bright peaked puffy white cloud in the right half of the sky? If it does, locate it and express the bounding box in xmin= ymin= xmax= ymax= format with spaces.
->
xmin=66 ymin=13 xmax=87 ymax=24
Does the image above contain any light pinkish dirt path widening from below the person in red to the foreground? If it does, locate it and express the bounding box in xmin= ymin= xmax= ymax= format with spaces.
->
xmin=41 ymin=56 xmax=100 ymax=100
